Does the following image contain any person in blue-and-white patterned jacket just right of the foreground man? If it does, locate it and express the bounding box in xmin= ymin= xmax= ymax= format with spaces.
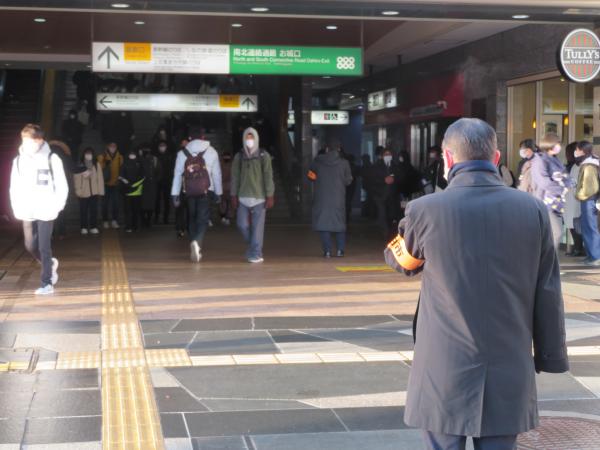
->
xmin=531 ymin=133 xmax=572 ymax=250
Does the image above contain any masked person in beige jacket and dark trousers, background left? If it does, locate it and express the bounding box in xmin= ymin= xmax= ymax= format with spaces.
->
xmin=73 ymin=147 xmax=104 ymax=235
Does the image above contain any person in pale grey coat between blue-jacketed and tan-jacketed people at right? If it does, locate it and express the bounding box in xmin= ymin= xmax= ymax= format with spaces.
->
xmin=563 ymin=142 xmax=585 ymax=257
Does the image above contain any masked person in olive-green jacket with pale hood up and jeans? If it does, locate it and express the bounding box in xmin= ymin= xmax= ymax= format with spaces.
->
xmin=230 ymin=128 xmax=275 ymax=263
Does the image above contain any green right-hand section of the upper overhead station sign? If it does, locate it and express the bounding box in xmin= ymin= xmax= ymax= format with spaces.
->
xmin=229 ymin=45 xmax=363 ymax=76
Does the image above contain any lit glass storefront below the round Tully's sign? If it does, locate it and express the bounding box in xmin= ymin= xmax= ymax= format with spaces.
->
xmin=507 ymin=74 xmax=600 ymax=174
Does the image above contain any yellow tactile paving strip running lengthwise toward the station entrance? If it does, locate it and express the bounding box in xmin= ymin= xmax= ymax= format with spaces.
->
xmin=101 ymin=233 xmax=164 ymax=450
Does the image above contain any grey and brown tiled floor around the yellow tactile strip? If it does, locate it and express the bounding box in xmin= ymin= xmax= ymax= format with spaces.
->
xmin=0 ymin=226 xmax=600 ymax=450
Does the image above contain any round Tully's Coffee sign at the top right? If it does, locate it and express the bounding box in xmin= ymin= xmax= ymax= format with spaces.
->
xmin=560 ymin=28 xmax=600 ymax=83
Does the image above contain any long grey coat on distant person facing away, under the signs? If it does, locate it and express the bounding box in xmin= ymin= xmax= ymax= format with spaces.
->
xmin=310 ymin=150 xmax=352 ymax=233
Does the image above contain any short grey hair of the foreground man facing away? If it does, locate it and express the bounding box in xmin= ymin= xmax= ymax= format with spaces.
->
xmin=443 ymin=118 xmax=498 ymax=162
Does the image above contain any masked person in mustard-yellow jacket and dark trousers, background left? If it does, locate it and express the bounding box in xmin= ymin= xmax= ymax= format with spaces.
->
xmin=98 ymin=142 xmax=123 ymax=229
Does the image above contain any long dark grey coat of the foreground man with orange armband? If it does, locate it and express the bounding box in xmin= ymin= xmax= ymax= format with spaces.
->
xmin=400 ymin=164 xmax=568 ymax=436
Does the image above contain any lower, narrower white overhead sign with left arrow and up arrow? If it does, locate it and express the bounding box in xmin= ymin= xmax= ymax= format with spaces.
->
xmin=96 ymin=93 xmax=258 ymax=112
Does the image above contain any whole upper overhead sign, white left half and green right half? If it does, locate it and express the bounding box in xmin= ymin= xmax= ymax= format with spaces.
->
xmin=92 ymin=42 xmax=363 ymax=76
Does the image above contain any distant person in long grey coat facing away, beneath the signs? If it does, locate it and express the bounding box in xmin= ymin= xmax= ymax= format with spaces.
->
xmin=308 ymin=145 xmax=352 ymax=258
